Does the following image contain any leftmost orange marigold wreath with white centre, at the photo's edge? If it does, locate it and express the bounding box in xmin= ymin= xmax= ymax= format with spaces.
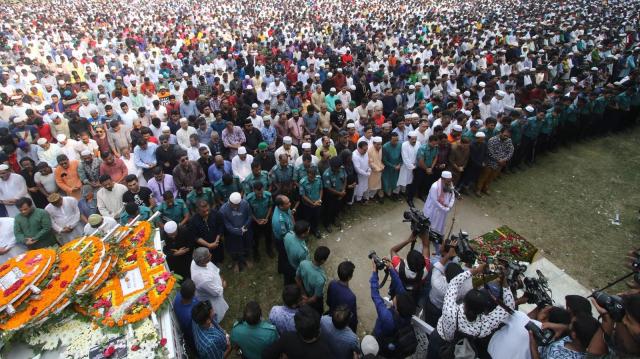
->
xmin=0 ymin=248 xmax=56 ymax=310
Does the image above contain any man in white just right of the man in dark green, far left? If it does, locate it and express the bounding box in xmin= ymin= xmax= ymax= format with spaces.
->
xmin=44 ymin=193 xmax=83 ymax=244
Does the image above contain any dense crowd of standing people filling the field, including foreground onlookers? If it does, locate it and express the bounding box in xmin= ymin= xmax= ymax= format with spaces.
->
xmin=0 ymin=0 xmax=640 ymax=358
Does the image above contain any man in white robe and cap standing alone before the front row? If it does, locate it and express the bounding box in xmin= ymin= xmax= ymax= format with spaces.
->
xmin=422 ymin=171 xmax=456 ymax=235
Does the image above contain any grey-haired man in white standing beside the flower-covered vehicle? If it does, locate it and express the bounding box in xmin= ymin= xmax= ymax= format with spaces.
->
xmin=191 ymin=247 xmax=229 ymax=323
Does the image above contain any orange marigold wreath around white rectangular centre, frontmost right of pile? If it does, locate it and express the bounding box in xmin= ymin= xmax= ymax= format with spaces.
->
xmin=79 ymin=247 xmax=176 ymax=327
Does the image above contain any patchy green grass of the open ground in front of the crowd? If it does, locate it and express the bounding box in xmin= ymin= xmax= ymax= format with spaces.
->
xmin=222 ymin=128 xmax=640 ymax=329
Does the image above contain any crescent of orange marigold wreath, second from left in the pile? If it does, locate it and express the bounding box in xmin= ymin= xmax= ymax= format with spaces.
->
xmin=0 ymin=251 xmax=81 ymax=330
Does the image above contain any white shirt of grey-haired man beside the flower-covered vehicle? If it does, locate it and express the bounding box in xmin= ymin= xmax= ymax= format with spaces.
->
xmin=191 ymin=261 xmax=229 ymax=323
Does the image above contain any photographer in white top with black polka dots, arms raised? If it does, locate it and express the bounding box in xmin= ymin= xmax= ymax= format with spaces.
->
xmin=427 ymin=264 xmax=515 ymax=359
